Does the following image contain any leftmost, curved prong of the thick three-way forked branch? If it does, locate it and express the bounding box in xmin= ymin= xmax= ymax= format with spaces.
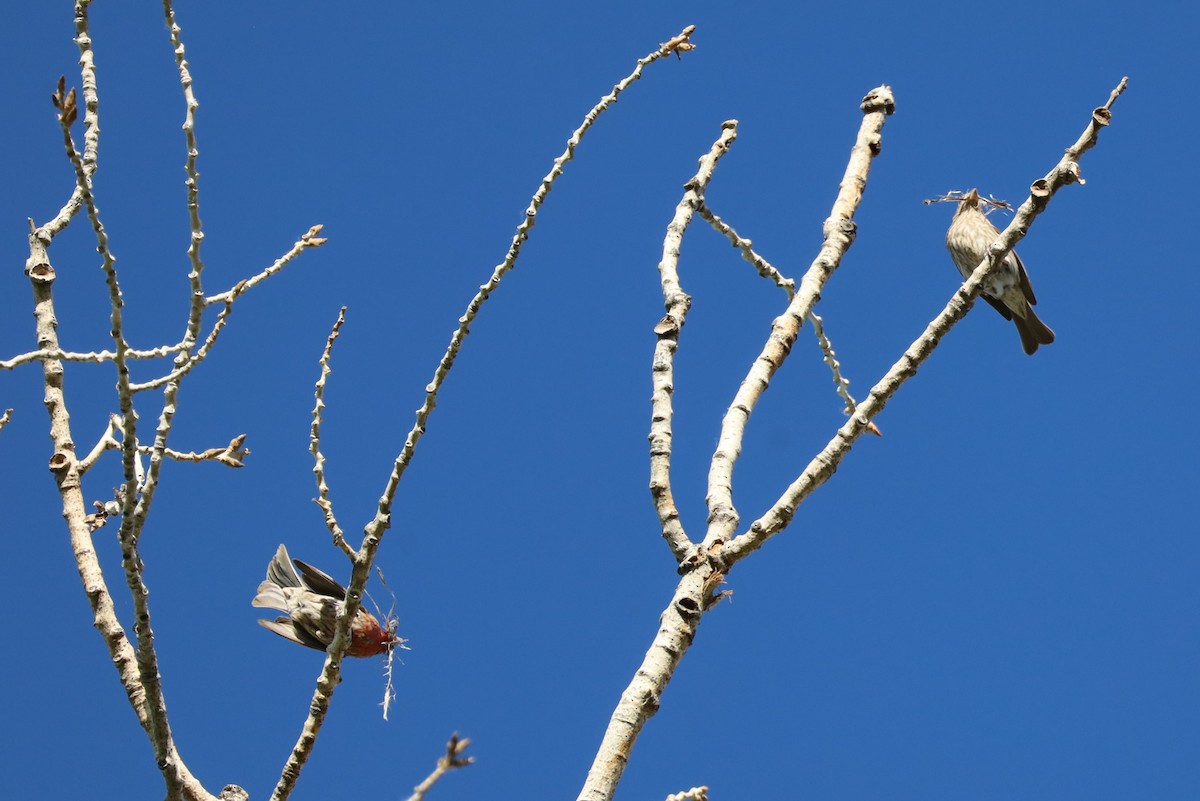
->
xmin=649 ymin=120 xmax=738 ymax=562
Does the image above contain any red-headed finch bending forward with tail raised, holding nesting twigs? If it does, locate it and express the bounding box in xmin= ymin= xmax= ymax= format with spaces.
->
xmin=251 ymin=546 xmax=404 ymax=657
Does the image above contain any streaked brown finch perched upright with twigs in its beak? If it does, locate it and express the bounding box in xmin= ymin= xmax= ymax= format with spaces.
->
xmin=946 ymin=189 xmax=1054 ymax=355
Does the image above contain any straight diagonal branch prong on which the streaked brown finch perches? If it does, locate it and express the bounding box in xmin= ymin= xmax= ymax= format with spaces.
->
xmin=721 ymin=78 xmax=1128 ymax=565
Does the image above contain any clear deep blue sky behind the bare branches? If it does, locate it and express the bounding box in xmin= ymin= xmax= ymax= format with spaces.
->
xmin=0 ymin=0 xmax=1200 ymax=801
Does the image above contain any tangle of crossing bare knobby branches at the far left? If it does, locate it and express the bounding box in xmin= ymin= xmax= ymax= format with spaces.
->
xmin=19 ymin=0 xmax=338 ymax=799
